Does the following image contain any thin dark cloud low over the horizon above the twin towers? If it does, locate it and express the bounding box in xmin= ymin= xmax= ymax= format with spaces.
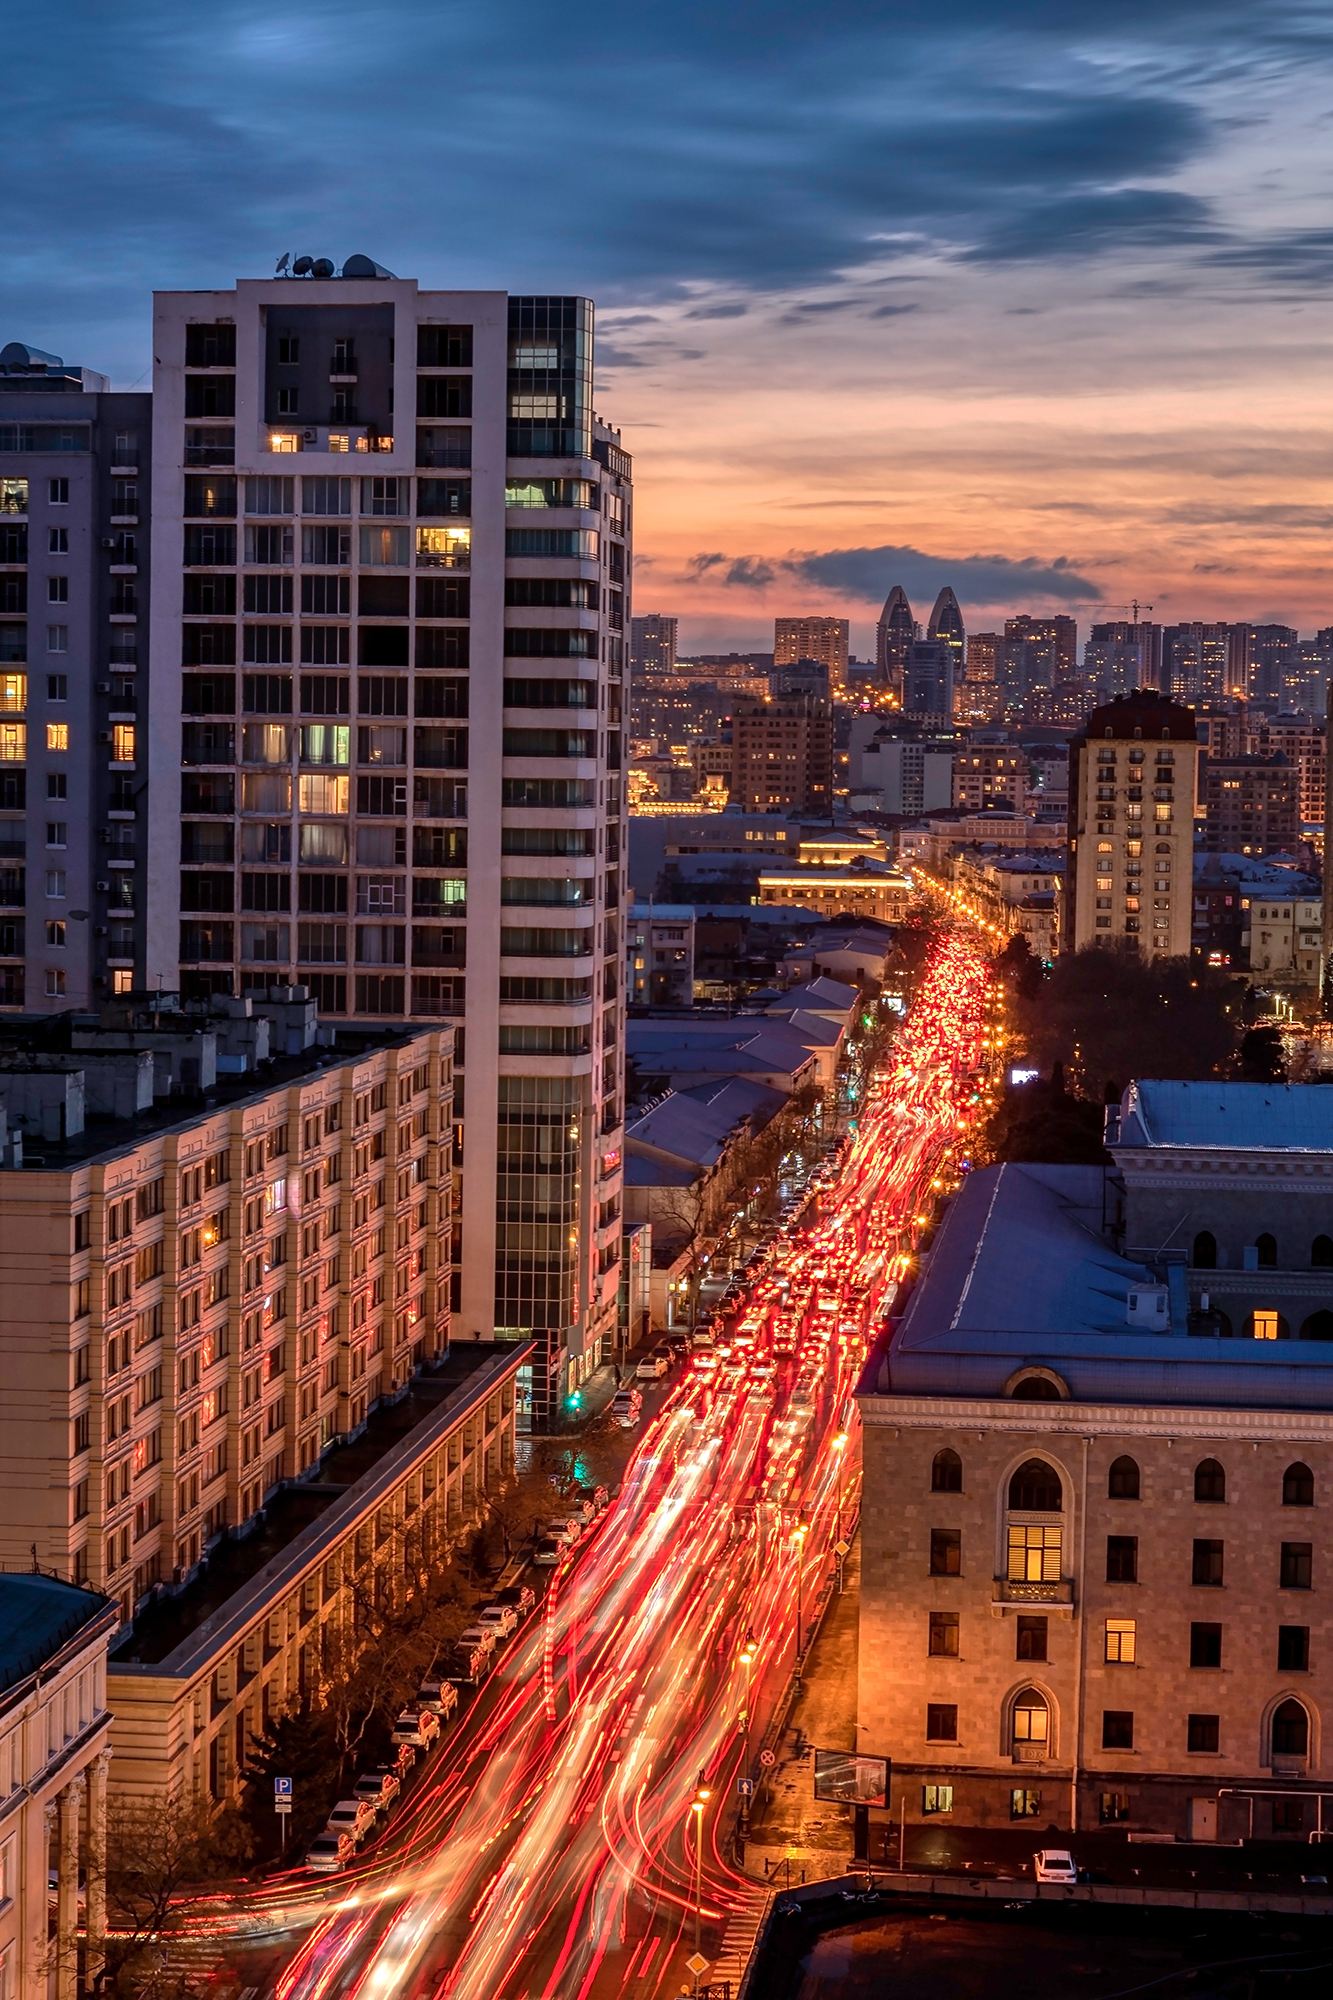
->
xmin=687 ymin=544 xmax=1103 ymax=606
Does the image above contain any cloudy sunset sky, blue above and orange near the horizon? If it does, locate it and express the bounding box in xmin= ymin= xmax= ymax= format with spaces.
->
xmin=10 ymin=0 xmax=1333 ymax=652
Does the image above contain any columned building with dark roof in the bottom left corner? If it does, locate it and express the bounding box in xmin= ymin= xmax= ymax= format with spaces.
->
xmin=0 ymin=1572 xmax=118 ymax=2000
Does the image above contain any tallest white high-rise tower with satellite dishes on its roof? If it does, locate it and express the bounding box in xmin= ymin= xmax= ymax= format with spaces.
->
xmin=146 ymin=258 xmax=630 ymax=1422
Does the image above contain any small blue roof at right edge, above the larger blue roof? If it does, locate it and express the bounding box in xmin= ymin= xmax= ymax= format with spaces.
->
xmin=1113 ymin=1078 xmax=1333 ymax=1152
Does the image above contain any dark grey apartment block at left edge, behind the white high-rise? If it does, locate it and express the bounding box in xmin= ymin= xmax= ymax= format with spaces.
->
xmin=0 ymin=342 xmax=151 ymax=1014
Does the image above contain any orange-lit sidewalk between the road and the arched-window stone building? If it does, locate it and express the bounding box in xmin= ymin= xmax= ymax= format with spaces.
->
xmin=745 ymin=1536 xmax=861 ymax=1882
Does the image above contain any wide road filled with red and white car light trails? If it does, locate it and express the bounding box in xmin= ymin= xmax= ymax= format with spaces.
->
xmin=200 ymin=934 xmax=985 ymax=2000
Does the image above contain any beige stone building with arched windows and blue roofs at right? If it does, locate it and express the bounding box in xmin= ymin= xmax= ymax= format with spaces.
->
xmin=859 ymin=1084 xmax=1333 ymax=1844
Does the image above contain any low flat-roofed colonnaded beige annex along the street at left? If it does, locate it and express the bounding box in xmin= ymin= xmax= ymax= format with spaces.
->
xmin=108 ymin=1342 xmax=520 ymax=1802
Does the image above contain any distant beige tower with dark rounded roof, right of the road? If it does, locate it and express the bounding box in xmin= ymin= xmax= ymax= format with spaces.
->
xmin=1061 ymin=688 xmax=1199 ymax=958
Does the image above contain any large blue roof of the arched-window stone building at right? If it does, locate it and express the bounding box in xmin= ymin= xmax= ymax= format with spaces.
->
xmin=863 ymin=1160 xmax=1333 ymax=1410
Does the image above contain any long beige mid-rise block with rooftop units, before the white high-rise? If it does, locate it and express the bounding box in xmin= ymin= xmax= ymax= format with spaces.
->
xmin=0 ymin=998 xmax=452 ymax=1622
